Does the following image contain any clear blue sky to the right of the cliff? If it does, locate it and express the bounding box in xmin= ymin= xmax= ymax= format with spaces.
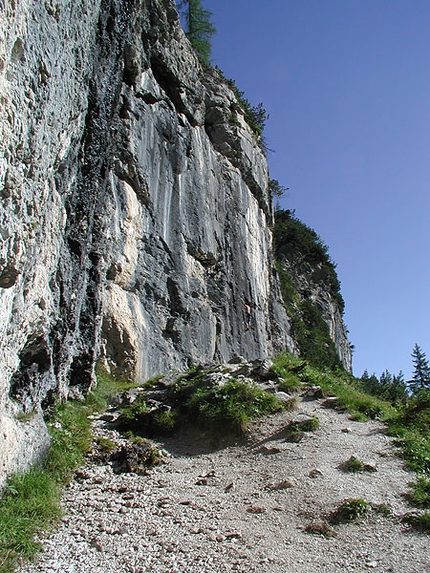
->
xmin=203 ymin=0 xmax=430 ymax=378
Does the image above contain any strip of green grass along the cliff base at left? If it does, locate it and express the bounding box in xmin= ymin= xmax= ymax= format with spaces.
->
xmin=0 ymin=373 xmax=137 ymax=573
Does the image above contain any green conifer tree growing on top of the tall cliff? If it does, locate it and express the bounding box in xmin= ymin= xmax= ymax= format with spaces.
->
xmin=178 ymin=0 xmax=216 ymax=67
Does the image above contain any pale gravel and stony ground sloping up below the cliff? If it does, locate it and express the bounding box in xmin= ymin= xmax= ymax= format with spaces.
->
xmin=20 ymin=399 xmax=430 ymax=573
